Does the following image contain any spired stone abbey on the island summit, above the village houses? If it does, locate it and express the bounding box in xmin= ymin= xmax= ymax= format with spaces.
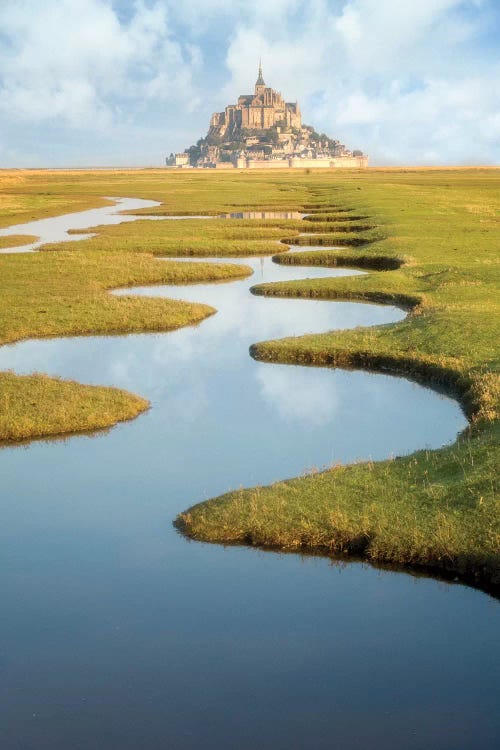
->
xmin=208 ymin=64 xmax=302 ymax=137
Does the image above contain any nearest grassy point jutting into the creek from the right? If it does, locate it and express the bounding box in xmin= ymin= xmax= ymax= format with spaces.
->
xmin=177 ymin=424 xmax=500 ymax=591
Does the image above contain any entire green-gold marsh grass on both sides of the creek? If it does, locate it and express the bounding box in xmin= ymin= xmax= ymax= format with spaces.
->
xmin=0 ymin=169 xmax=500 ymax=592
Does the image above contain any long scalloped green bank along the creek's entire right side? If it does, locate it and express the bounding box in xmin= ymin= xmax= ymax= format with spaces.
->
xmin=177 ymin=170 xmax=500 ymax=592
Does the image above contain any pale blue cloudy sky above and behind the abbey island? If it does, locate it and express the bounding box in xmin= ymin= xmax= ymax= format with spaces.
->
xmin=0 ymin=0 xmax=500 ymax=167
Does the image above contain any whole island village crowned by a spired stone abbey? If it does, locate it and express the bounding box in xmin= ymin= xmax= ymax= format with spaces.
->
xmin=166 ymin=64 xmax=368 ymax=169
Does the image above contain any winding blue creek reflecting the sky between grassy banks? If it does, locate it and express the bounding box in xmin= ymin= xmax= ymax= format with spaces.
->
xmin=0 ymin=201 xmax=500 ymax=750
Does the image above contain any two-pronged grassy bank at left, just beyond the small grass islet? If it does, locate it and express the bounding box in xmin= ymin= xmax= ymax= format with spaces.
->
xmin=0 ymin=251 xmax=250 ymax=343
